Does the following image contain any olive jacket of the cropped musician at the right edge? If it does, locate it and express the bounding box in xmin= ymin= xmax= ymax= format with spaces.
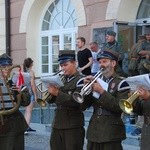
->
xmin=133 ymin=98 xmax=150 ymax=150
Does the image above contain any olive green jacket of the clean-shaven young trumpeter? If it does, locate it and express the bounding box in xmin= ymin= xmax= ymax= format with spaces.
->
xmin=50 ymin=72 xmax=84 ymax=129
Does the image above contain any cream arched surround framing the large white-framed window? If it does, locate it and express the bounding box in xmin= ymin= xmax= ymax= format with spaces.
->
xmin=19 ymin=0 xmax=86 ymax=76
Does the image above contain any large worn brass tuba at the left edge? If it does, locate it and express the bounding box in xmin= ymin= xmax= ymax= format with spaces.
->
xmin=0 ymin=65 xmax=21 ymax=124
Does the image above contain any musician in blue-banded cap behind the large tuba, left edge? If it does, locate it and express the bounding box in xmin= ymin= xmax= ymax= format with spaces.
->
xmin=0 ymin=54 xmax=28 ymax=150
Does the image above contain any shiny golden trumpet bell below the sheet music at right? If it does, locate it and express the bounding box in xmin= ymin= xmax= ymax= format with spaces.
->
xmin=119 ymin=91 xmax=139 ymax=114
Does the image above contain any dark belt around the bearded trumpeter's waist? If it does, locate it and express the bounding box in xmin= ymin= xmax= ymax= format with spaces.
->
xmin=94 ymin=107 xmax=114 ymax=116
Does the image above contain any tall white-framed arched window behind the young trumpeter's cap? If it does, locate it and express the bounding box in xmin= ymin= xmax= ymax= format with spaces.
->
xmin=41 ymin=0 xmax=77 ymax=74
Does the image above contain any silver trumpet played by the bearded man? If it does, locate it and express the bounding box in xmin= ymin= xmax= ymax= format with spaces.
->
xmin=73 ymin=69 xmax=103 ymax=103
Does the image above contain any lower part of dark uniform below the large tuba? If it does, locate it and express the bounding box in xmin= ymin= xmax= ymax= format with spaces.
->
xmin=0 ymin=111 xmax=28 ymax=150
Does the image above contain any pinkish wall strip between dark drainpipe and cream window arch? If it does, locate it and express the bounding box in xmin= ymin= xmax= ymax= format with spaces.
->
xmin=10 ymin=0 xmax=26 ymax=64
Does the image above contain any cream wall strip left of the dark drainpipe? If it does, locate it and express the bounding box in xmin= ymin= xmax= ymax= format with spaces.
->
xmin=0 ymin=0 xmax=6 ymax=55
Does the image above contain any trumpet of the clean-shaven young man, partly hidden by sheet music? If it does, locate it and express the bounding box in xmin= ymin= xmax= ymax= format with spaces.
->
xmin=36 ymin=70 xmax=65 ymax=107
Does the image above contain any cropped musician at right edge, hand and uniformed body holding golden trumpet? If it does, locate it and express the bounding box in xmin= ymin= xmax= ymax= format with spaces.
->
xmin=133 ymin=87 xmax=150 ymax=150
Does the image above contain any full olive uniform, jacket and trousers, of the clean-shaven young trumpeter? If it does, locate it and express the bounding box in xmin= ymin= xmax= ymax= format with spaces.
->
xmin=50 ymin=73 xmax=84 ymax=150
